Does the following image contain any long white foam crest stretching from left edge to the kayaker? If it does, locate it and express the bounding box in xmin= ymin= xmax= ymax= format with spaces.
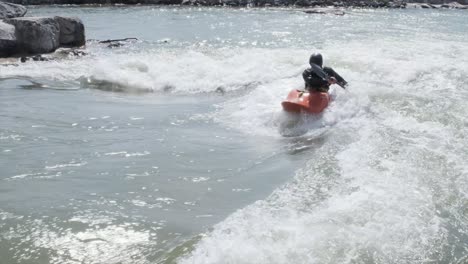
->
xmin=2 ymin=47 xmax=306 ymax=94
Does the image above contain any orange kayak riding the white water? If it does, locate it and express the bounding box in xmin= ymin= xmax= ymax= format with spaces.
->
xmin=281 ymin=89 xmax=330 ymax=114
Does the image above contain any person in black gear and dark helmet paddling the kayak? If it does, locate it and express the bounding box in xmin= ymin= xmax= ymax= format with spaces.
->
xmin=302 ymin=53 xmax=348 ymax=92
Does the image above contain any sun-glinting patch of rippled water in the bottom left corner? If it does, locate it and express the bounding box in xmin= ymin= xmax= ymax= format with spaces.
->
xmin=0 ymin=211 xmax=163 ymax=264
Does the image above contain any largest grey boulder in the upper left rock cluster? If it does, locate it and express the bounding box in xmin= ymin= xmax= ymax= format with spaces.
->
xmin=6 ymin=17 xmax=60 ymax=53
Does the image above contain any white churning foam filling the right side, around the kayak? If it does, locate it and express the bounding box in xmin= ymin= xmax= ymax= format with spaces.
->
xmin=180 ymin=35 xmax=468 ymax=263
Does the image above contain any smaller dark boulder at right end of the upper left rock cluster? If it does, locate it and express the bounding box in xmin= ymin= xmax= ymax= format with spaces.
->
xmin=54 ymin=16 xmax=86 ymax=47
